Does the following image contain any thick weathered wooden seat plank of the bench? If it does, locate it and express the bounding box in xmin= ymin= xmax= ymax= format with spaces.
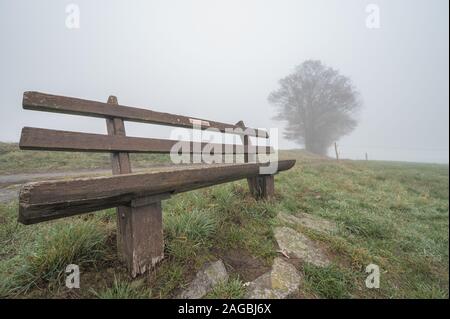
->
xmin=19 ymin=160 xmax=295 ymax=224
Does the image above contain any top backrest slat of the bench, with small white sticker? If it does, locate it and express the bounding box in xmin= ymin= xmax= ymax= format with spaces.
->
xmin=22 ymin=92 xmax=269 ymax=138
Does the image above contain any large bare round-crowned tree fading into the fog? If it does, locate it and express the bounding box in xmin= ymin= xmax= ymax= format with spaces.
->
xmin=269 ymin=60 xmax=362 ymax=155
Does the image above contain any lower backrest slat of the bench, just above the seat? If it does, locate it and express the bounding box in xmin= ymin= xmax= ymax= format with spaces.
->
xmin=19 ymin=127 xmax=274 ymax=154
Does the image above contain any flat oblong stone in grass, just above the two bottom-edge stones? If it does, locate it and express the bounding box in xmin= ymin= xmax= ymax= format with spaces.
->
xmin=274 ymin=227 xmax=330 ymax=267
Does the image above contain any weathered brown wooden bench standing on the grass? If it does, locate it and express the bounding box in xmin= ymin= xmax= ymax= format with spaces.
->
xmin=19 ymin=92 xmax=295 ymax=277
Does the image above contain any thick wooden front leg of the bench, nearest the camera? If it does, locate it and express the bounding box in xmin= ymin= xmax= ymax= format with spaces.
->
xmin=117 ymin=200 xmax=164 ymax=277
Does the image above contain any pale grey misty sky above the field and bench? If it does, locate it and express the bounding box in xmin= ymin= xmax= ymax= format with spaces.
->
xmin=0 ymin=0 xmax=449 ymax=163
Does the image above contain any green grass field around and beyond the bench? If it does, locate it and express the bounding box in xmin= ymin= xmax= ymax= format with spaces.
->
xmin=0 ymin=144 xmax=449 ymax=298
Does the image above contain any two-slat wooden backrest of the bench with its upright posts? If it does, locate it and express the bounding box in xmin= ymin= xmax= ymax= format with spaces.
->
xmin=19 ymin=92 xmax=273 ymax=158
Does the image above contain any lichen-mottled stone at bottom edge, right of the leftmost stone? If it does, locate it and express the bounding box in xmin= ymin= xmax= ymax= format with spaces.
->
xmin=246 ymin=258 xmax=301 ymax=299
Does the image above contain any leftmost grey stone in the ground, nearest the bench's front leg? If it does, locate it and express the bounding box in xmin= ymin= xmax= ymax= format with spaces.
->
xmin=178 ymin=260 xmax=228 ymax=299
